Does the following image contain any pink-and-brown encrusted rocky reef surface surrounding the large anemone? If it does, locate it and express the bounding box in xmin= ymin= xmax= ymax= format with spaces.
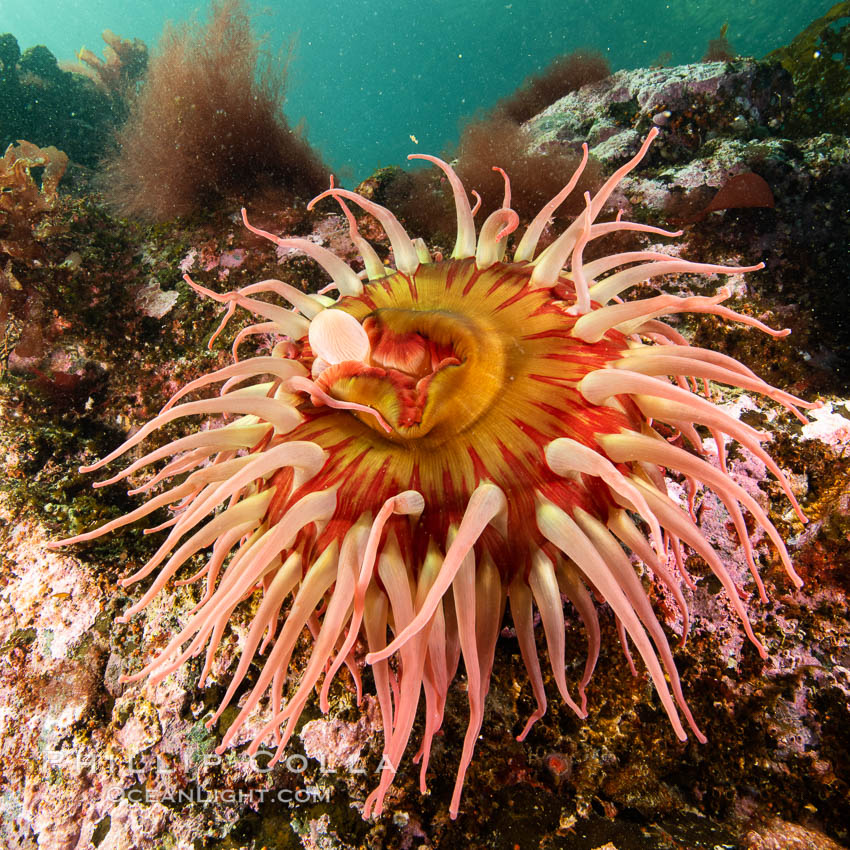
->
xmin=0 ymin=13 xmax=850 ymax=850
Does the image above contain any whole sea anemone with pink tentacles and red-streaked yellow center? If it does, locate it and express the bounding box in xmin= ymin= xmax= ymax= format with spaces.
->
xmin=49 ymin=129 xmax=814 ymax=817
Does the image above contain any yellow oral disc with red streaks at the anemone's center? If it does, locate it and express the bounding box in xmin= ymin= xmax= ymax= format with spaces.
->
xmin=291 ymin=260 xmax=625 ymax=528
